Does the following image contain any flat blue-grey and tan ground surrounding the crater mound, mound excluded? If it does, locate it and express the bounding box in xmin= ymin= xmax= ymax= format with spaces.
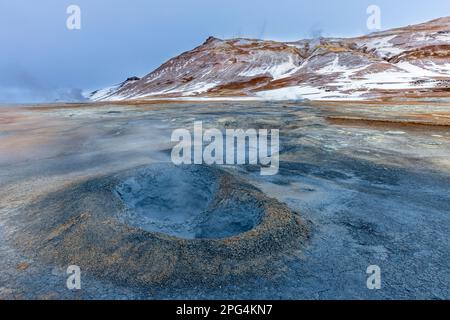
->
xmin=0 ymin=102 xmax=450 ymax=299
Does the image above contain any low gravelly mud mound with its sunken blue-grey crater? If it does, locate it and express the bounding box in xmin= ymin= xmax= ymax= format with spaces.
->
xmin=16 ymin=165 xmax=307 ymax=285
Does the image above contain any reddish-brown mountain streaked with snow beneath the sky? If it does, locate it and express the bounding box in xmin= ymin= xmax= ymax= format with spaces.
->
xmin=90 ymin=17 xmax=450 ymax=101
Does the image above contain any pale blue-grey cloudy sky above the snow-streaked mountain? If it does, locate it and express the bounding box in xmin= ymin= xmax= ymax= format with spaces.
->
xmin=0 ymin=0 xmax=450 ymax=102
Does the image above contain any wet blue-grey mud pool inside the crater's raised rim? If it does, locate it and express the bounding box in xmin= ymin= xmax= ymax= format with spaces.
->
xmin=115 ymin=165 xmax=264 ymax=239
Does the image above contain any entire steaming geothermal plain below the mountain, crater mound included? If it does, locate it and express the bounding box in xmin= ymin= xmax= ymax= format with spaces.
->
xmin=0 ymin=100 xmax=450 ymax=299
